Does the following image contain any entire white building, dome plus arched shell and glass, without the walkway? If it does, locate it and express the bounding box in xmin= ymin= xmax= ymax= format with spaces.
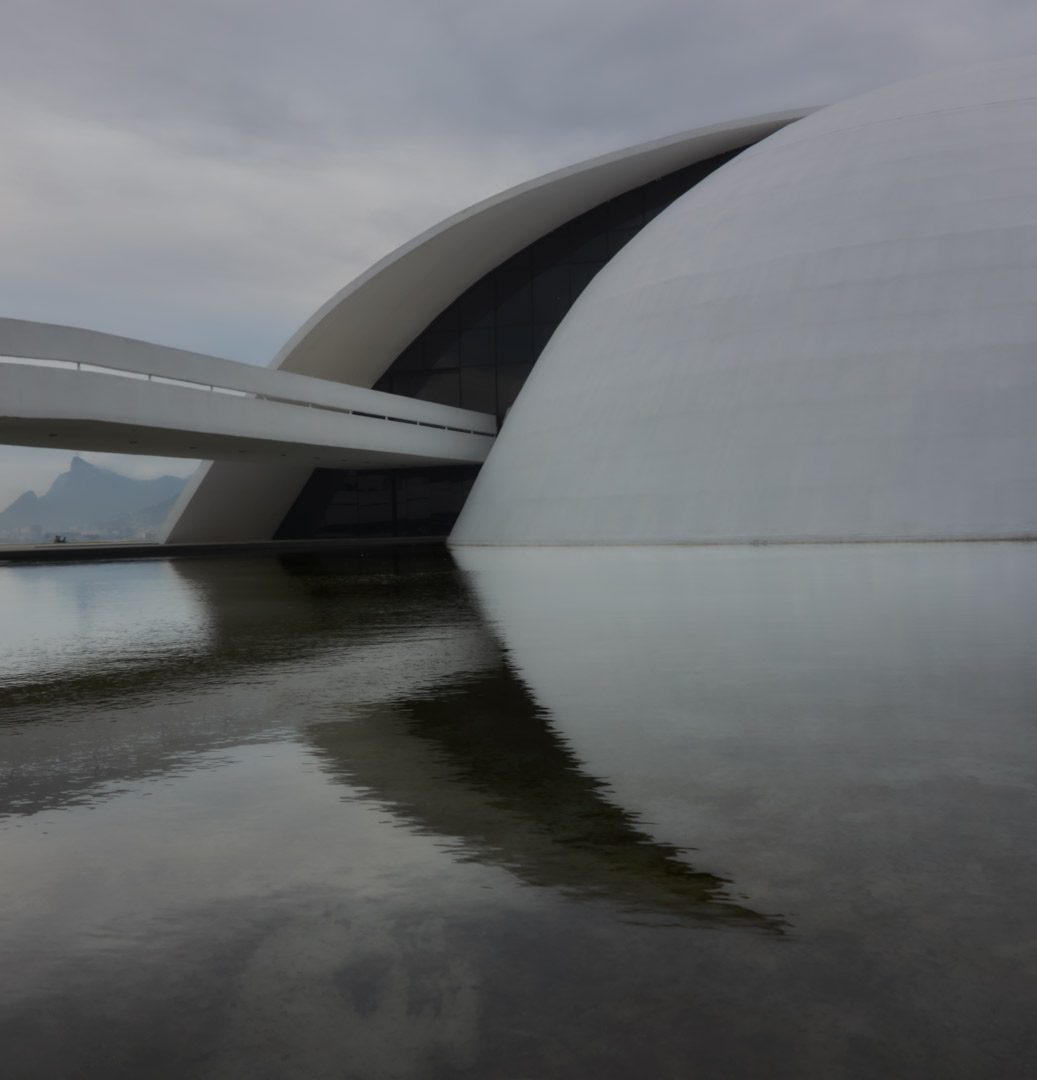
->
xmin=134 ymin=58 xmax=1037 ymax=544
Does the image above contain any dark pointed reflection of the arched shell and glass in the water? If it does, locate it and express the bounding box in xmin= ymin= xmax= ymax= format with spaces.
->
xmin=306 ymin=664 xmax=786 ymax=934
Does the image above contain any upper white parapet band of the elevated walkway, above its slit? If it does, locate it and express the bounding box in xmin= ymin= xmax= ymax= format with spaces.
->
xmin=0 ymin=318 xmax=497 ymax=436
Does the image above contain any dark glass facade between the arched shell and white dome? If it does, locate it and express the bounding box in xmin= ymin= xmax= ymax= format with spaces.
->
xmin=275 ymin=150 xmax=740 ymax=540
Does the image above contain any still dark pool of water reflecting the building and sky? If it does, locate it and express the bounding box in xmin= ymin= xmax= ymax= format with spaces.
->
xmin=0 ymin=544 xmax=1037 ymax=1080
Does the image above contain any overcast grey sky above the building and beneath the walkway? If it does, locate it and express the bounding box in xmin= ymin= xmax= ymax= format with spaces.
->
xmin=0 ymin=0 xmax=1037 ymax=509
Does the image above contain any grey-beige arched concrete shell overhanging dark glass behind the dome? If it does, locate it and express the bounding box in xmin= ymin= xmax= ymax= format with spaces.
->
xmin=163 ymin=109 xmax=811 ymax=542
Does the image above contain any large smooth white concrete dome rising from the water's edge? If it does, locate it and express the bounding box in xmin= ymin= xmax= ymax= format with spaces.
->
xmin=452 ymin=58 xmax=1037 ymax=544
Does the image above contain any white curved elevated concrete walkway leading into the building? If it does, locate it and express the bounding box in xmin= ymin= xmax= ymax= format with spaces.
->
xmin=0 ymin=319 xmax=497 ymax=469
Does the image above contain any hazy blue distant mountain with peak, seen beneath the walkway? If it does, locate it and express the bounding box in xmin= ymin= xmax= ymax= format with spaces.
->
xmin=0 ymin=457 xmax=187 ymax=543
